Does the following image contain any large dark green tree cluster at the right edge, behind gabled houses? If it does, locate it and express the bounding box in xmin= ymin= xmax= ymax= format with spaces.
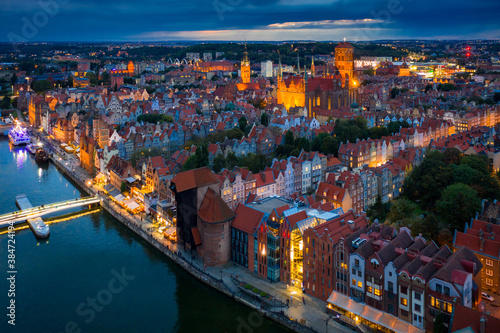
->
xmin=367 ymin=148 xmax=500 ymax=245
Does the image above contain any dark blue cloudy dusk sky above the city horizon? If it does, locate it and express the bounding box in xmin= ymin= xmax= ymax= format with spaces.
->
xmin=0 ymin=0 xmax=500 ymax=41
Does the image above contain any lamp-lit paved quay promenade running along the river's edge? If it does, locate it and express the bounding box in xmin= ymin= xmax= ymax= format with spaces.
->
xmin=30 ymin=132 xmax=354 ymax=333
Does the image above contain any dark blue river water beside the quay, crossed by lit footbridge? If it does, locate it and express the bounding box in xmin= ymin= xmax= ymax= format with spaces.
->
xmin=0 ymin=138 xmax=288 ymax=333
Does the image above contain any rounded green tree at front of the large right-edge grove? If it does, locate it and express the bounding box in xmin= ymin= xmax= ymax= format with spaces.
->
xmin=436 ymin=183 xmax=481 ymax=231
